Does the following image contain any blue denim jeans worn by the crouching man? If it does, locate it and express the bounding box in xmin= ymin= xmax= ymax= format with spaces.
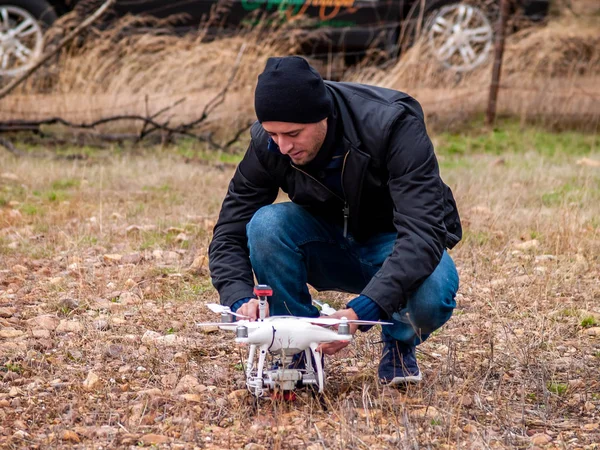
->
xmin=246 ymin=202 xmax=458 ymax=345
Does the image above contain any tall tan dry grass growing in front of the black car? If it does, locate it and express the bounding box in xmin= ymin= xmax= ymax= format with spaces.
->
xmin=0 ymin=6 xmax=600 ymax=134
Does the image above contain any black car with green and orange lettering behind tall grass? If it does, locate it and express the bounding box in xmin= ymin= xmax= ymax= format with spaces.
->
xmin=0 ymin=0 xmax=549 ymax=75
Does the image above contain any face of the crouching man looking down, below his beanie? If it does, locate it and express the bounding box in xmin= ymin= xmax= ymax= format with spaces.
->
xmin=262 ymin=119 xmax=327 ymax=166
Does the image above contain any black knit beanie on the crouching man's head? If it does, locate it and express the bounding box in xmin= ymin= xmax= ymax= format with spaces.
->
xmin=254 ymin=56 xmax=332 ymax=123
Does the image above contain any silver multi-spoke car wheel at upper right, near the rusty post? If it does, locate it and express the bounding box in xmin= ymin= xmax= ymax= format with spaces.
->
xmin=425 ymin=3 xmax=494 ymax=72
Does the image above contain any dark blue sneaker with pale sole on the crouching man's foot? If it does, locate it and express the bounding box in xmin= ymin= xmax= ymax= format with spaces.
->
xmin=378 ymin=337 xmax=422 ymax=386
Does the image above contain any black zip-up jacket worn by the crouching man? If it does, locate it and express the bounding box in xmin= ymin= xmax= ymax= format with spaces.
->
xmin=209 ymin=82 xmax=462 ymax=316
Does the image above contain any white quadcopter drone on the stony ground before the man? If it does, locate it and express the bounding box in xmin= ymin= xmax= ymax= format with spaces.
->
xmin=197 ymin=284 xmax=390 ymax=398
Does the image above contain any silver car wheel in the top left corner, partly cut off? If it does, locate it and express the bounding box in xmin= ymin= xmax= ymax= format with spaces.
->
xmin=0 ymin=0 xmax=56 ymax=76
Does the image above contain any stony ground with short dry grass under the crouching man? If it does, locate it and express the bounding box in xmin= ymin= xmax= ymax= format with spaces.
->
xmin=0 ymin=131 xmax=600 ymax=450
